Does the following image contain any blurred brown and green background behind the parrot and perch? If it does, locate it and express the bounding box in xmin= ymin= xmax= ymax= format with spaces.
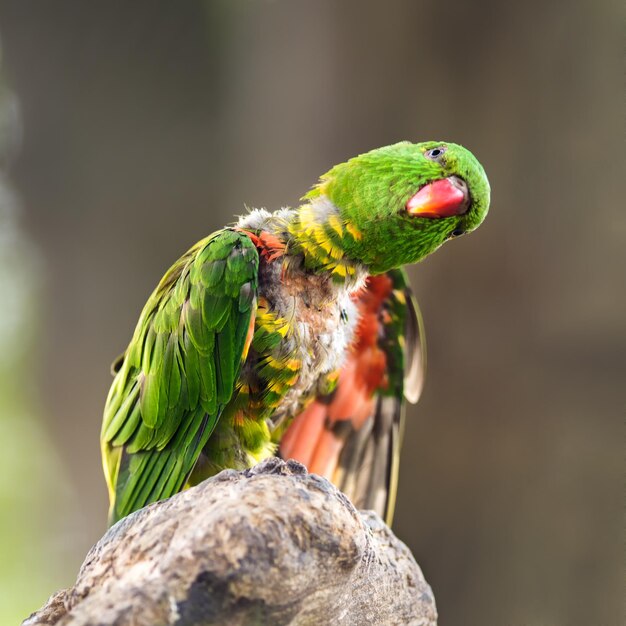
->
xmin=0 ymin=0 xmax=626 ymax=626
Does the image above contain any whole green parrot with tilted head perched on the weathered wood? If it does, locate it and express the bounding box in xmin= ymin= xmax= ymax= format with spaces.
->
xmin=101 ymin=141 xmax=490 ymax=524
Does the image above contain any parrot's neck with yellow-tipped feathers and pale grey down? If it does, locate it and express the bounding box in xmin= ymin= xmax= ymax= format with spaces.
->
xmin=238 ymin=196 xmax=368 ymax=291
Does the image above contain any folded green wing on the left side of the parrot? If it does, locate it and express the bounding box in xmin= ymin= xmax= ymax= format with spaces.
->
xmin=101 ymin=230 xmax=259 ymax=523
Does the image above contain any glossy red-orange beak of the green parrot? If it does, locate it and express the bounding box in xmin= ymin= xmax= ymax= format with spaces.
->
xmin=406 ymin=176 xmax=470 ymax=218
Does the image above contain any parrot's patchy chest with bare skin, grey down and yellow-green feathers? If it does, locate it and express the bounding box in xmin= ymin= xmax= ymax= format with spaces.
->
xmin=248 ymin=262 xmax=357 ymax=424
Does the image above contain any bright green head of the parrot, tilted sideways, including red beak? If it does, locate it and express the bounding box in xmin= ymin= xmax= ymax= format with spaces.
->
xmin=305 ymin=141 xmax=490 ymax=274
